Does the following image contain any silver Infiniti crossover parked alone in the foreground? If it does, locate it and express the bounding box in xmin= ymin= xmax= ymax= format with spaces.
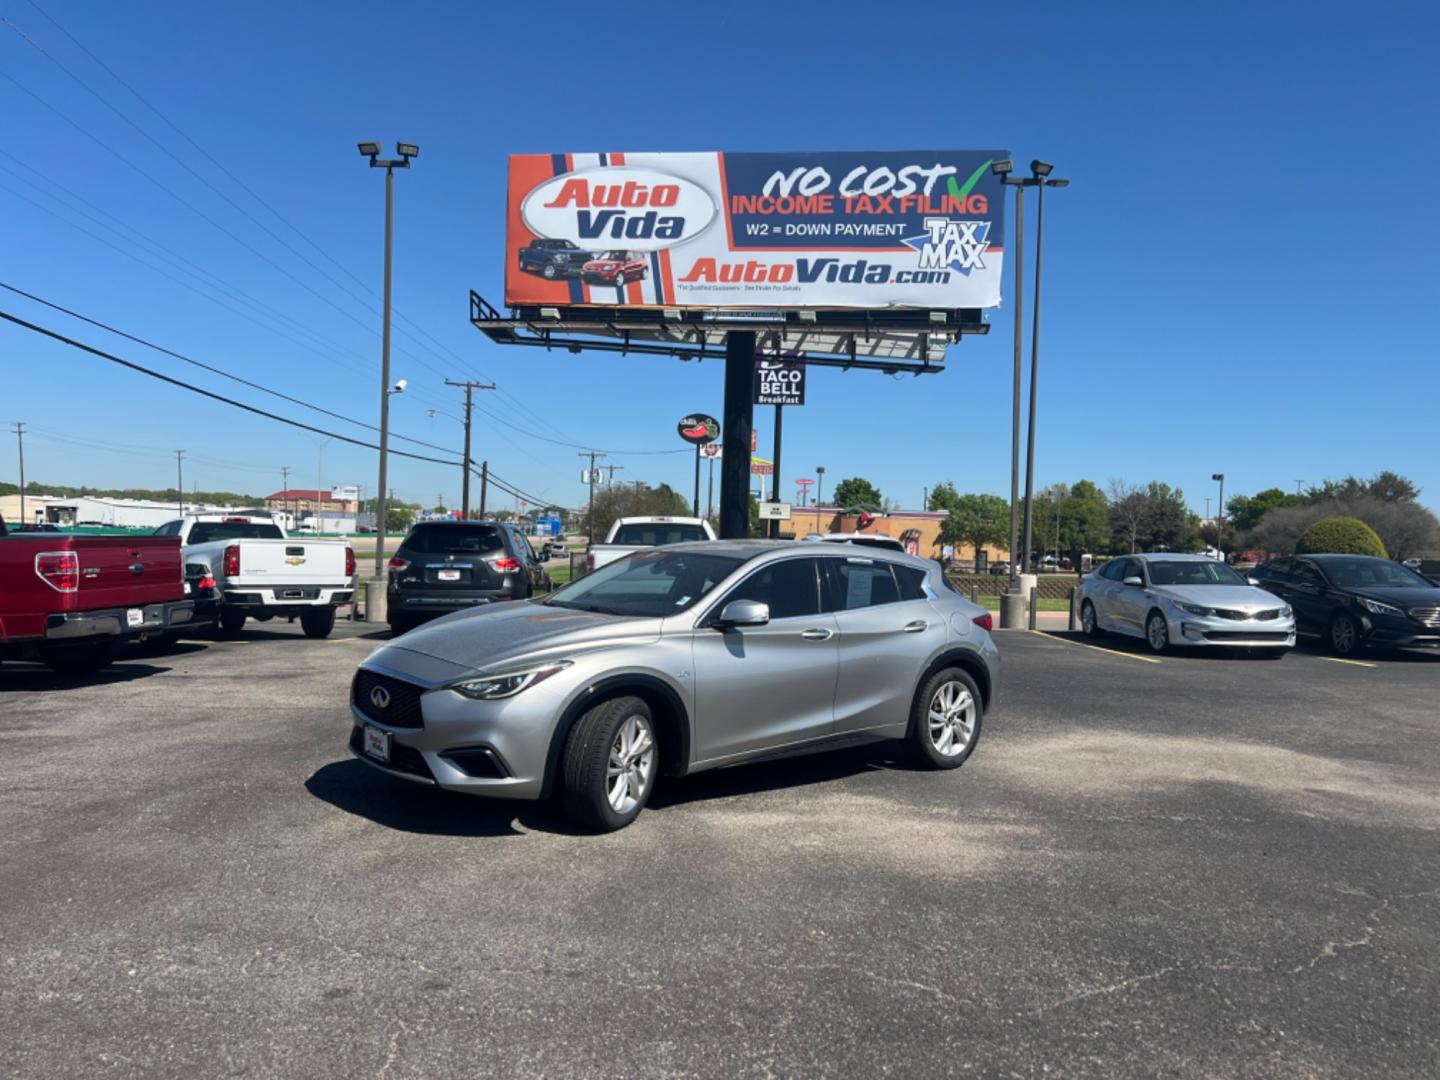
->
xmin=350 ymin=540 xmax=999 ymax=829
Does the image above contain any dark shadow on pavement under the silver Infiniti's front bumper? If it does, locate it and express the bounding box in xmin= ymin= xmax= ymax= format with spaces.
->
xmin=305 ymin=757 xmax=583 ymax=837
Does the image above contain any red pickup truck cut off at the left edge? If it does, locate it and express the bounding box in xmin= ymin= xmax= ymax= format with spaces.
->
xmin=0 ymin=518 xmax=194 ymax=675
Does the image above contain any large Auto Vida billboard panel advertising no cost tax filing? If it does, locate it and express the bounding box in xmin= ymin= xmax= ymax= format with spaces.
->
xmin=505 ymin=150 xmax=1009 ymax=310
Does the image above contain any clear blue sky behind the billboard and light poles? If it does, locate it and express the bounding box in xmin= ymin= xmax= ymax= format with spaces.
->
xmin=0 ymin=0 xmax=1440 ymax=511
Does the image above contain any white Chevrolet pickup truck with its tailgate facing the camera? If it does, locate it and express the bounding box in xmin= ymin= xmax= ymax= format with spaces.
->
xmin=156 ymin=513 xmax=356 ymax=638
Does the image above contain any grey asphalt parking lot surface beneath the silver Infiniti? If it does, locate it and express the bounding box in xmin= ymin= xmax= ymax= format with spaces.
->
xmin=0 ymin=624 xmax=1440 ymax=1077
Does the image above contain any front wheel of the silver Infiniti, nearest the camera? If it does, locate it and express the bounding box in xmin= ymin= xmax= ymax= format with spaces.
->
xmin=560 ymin=697 xmax=660 ymax=832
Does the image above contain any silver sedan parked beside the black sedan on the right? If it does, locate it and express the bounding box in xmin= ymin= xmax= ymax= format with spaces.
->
xmin=1079 ymin=553 xmax=1295 ymax=657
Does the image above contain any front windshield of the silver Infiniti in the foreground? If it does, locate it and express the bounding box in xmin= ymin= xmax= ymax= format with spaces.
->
xmin=544 ymin=550 xmax=744 ymax=618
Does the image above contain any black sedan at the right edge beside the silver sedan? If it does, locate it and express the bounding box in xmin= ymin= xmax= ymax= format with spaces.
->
xmin=1250 ymin=554 xmax=1440 ymax=657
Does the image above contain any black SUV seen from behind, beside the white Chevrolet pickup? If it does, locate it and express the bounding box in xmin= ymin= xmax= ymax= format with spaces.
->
xmin=386 ymin=521 xmax=552 ymax=636
